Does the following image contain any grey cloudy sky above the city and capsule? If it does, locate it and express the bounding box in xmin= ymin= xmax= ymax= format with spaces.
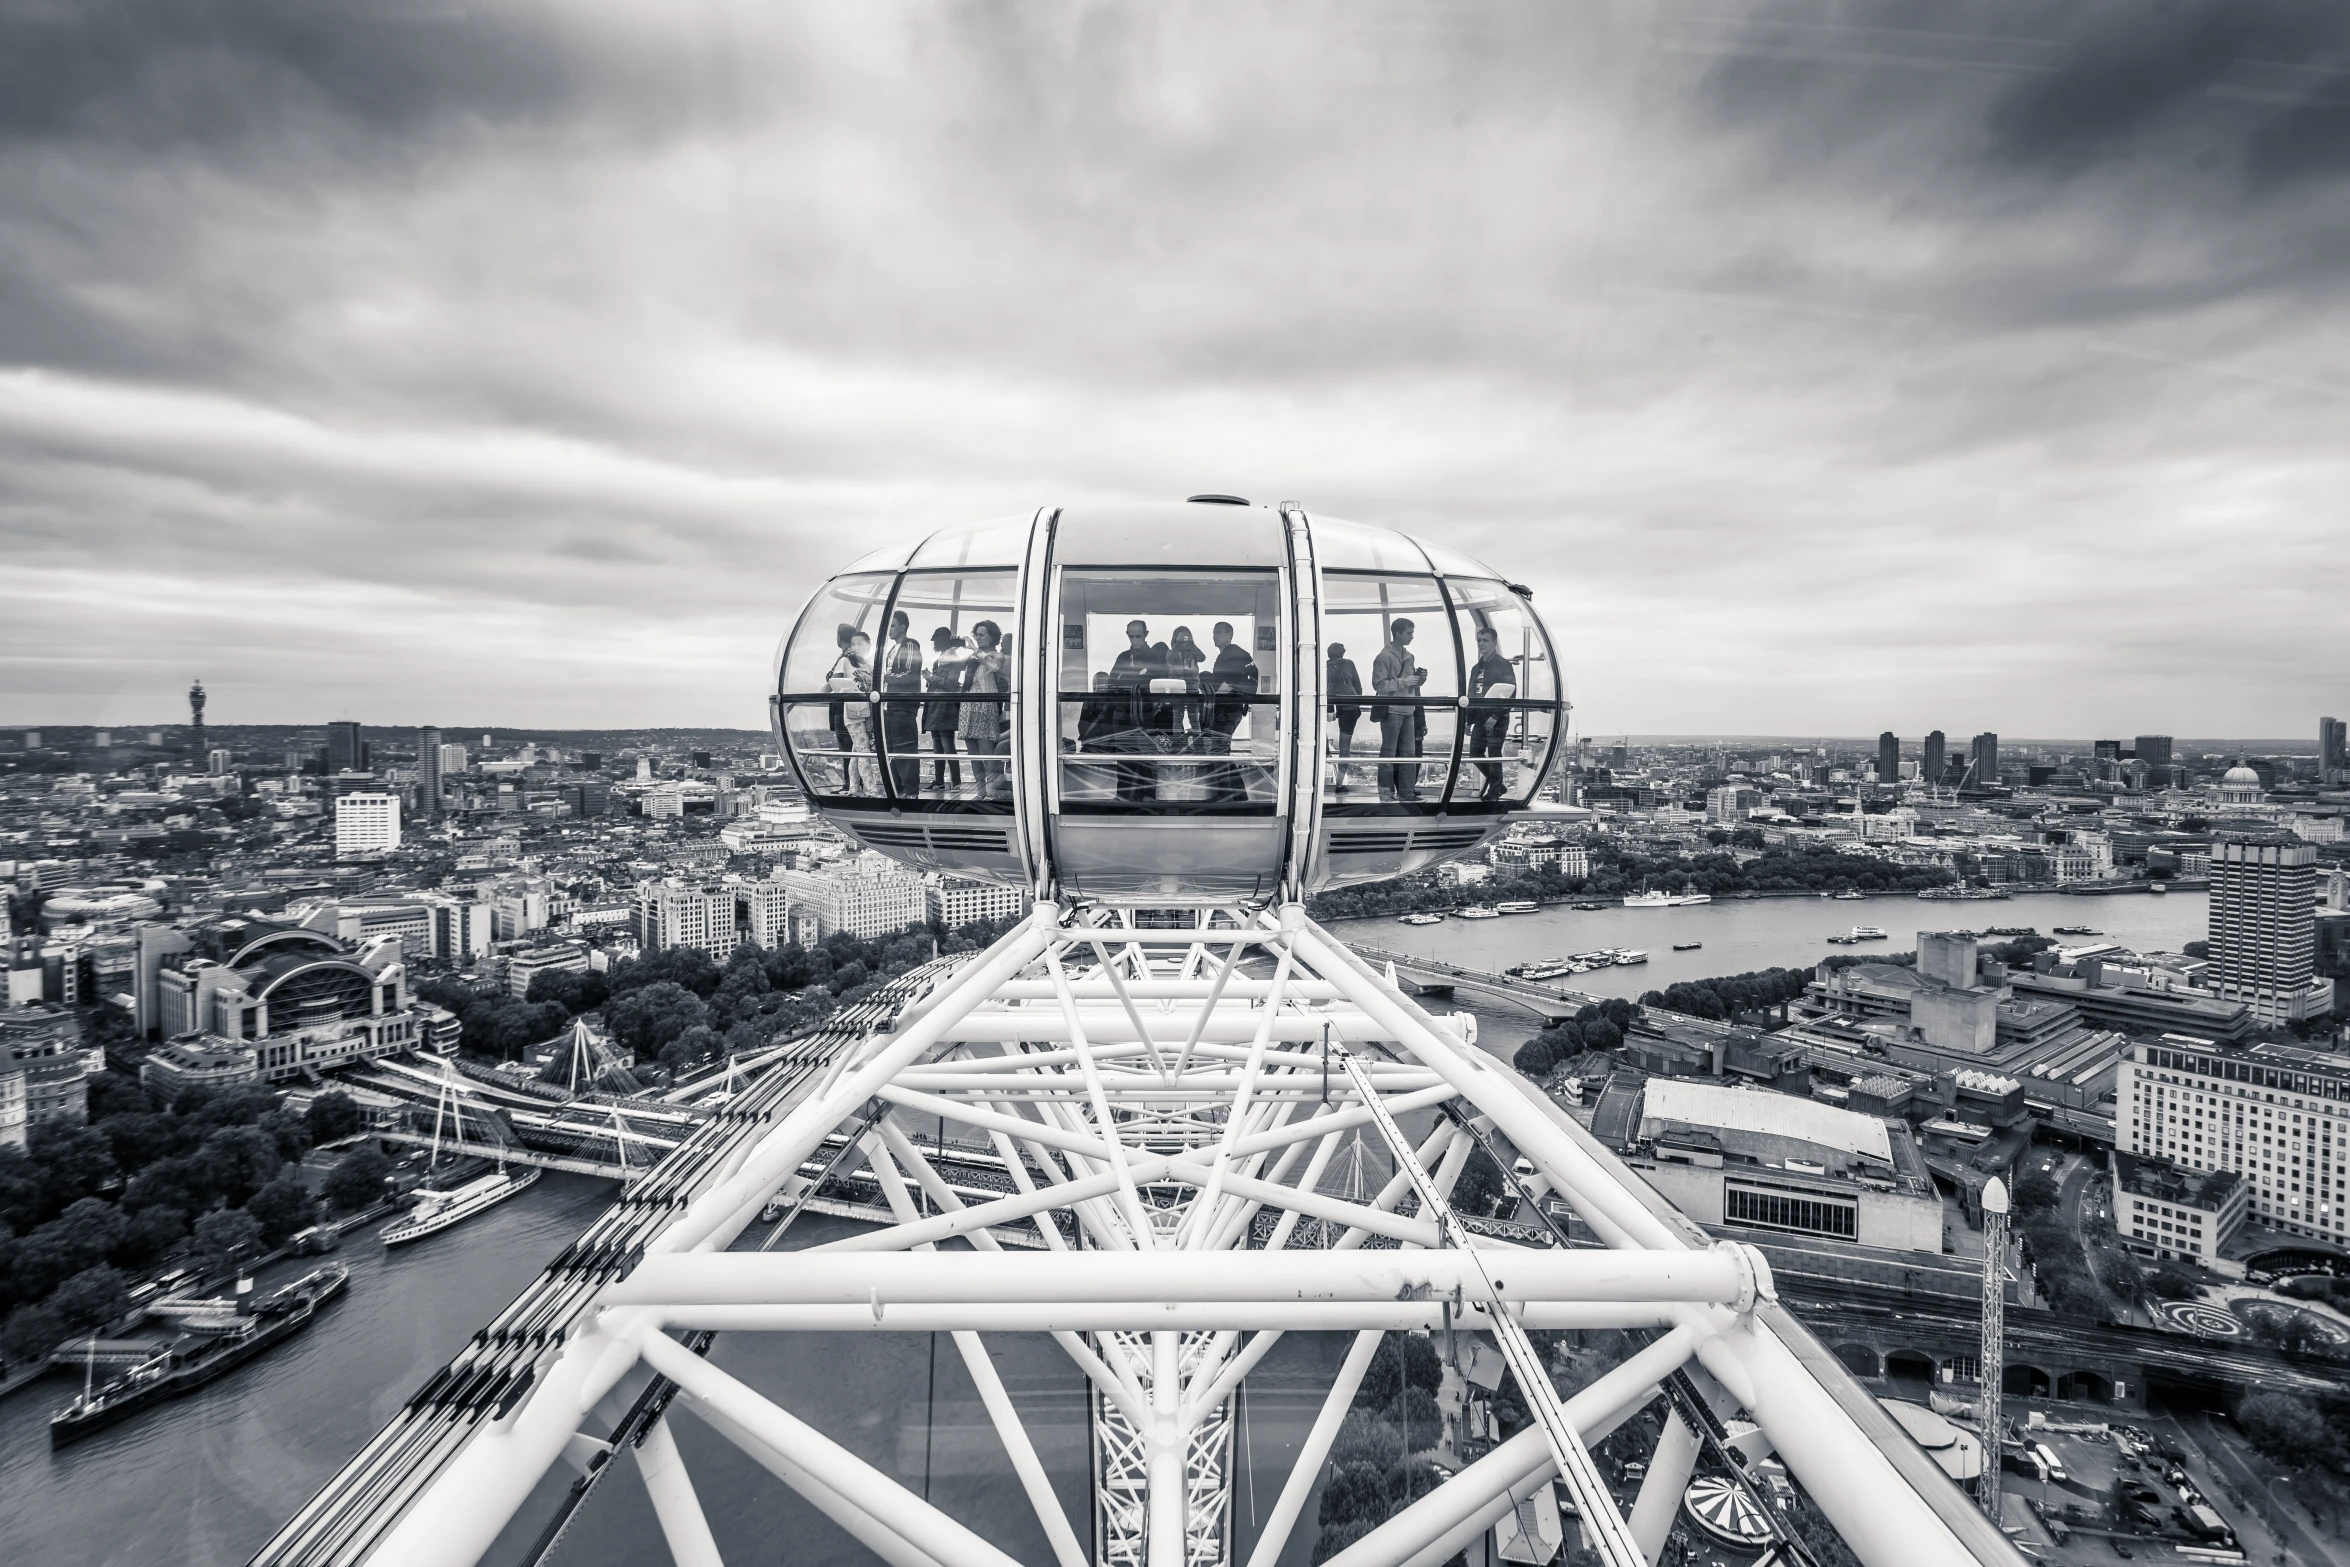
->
xmin=0 ymin=0 xmax=2350 ymax=735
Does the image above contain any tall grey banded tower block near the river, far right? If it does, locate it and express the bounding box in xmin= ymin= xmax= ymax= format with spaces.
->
xmin=2209 ymin=836 xmax=2334 ymax=1022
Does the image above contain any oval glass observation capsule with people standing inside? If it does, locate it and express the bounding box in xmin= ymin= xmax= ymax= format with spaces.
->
xmin=773 ymin=496 xmax=1567 ymax=907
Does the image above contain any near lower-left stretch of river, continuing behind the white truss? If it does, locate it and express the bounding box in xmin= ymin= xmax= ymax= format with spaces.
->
xmin=0 ymin=1175 xmax=1347 ymax=1567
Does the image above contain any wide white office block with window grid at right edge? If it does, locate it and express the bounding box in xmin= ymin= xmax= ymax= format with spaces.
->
xmin=2113 ymin=1034 xmax=2350 ymax=1243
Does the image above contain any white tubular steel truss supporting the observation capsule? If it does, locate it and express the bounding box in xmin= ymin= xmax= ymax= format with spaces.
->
xmin=336 ymin=904 xmax=2021 ymax=1567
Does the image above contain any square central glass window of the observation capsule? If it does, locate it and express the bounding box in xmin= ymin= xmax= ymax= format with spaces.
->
xmin=1058 ymin=569 xmax=1288 ymax=815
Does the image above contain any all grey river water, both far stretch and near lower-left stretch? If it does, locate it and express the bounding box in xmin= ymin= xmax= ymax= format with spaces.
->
xmin=0 ymin=893 xmax=2204 ymax=1567
